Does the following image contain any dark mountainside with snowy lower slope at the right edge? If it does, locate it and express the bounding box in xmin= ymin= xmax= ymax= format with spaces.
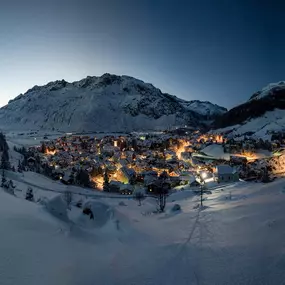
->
xmin=214 ymin=81 xmax=285 ymax=137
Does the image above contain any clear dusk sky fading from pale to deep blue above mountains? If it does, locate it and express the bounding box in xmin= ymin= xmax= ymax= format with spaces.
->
xmin=0 ymin=0 xmax=285 ymax=108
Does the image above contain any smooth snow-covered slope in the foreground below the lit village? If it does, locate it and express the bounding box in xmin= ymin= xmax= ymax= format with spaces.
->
xmin=0 ymin=172 xmax=285 ymax=285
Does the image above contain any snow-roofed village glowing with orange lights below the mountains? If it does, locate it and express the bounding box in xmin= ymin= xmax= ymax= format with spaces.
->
xmin=19 ymin=128 xmax=285 ymax=195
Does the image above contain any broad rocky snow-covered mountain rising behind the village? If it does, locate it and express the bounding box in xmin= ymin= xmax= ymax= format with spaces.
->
xmin=0 ymin=74 xmax=226 ymax=132
